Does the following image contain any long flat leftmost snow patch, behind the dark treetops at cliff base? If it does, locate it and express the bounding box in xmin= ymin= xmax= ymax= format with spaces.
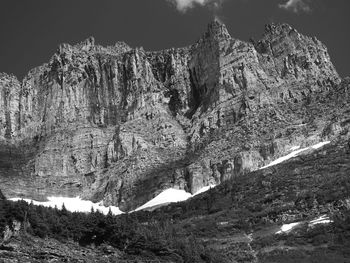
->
xmin=9 ymin=197 xmax=123 ymax=215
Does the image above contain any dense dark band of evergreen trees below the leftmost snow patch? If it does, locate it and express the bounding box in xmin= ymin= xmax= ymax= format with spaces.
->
xmin=0 ymin=200 xmax=230 ymax=262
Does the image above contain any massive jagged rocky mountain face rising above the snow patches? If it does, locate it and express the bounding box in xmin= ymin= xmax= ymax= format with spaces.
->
xmin=0 ymin=21 xmax=347 ymax=210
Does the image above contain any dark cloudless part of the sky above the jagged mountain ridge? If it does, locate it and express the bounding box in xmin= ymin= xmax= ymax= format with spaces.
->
xmin=0 ymin=0 xmax=350 ymax=78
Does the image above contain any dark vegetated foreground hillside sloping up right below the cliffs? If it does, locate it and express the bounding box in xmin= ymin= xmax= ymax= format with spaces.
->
xmin=0 ymin=140 xmax=350 ymax=262
